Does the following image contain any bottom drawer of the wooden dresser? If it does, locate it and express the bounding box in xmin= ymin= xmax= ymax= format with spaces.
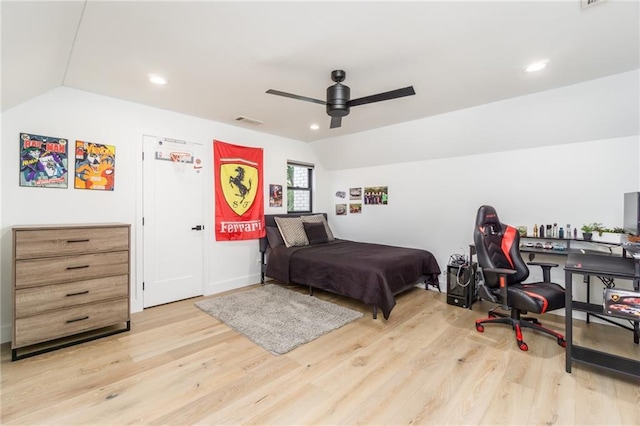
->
xmin=12 ymin=298 xmax=129 ymax=348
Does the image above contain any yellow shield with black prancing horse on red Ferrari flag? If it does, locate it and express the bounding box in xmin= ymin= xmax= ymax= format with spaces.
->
xmin=220 ymin=163 xmax=258 ymax=216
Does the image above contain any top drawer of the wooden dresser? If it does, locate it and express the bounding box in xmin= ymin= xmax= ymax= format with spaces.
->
xmin=14 ymin=226 xmax=129 ymax=259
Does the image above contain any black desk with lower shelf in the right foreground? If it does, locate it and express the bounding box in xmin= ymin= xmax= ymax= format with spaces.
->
xmin=564 ymin=253 xmax=640 ymax=377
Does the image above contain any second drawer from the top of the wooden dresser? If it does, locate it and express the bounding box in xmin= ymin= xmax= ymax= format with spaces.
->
xmin=15 ymin=251 xmax=129 ymax=288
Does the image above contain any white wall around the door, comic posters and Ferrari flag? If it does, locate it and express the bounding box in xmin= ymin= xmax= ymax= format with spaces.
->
xmin=0 ymin=87 xmax=326 ymax=342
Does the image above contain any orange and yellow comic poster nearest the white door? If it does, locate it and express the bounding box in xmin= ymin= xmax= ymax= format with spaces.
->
xmin=75 ymin=141 xmax=116 ymax=191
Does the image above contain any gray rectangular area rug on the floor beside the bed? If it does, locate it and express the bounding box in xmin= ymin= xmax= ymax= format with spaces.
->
xmin=195 ymin=284 xmax=362 ymax=355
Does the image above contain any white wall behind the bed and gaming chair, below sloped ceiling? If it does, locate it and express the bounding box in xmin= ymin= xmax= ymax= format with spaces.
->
xmin=327 ymin=137 xmax=640 ymax=288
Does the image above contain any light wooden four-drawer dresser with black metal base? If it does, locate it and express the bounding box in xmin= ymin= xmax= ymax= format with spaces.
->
xmin=11 ymin=224 xmax=131 ymax=361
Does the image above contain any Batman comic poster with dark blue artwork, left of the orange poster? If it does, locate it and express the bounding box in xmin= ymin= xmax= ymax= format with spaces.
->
xmin=20 ymin=133 xmax=69 ymax=188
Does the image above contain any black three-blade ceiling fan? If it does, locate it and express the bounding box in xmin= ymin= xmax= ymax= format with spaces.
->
xmin=267 ymin=70 xmax=416 ymax=129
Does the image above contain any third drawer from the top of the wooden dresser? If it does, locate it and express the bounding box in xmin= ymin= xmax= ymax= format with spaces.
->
xmin=15 ymin=275 xmax=129 ymax=318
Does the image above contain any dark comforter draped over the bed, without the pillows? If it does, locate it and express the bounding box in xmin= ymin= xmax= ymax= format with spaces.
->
xmin=266 ymin=240 xmax=440 ymax=319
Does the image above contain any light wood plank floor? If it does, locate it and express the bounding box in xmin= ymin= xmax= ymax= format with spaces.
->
xmin=0 ymin=288 xmax=640 ymax=425
